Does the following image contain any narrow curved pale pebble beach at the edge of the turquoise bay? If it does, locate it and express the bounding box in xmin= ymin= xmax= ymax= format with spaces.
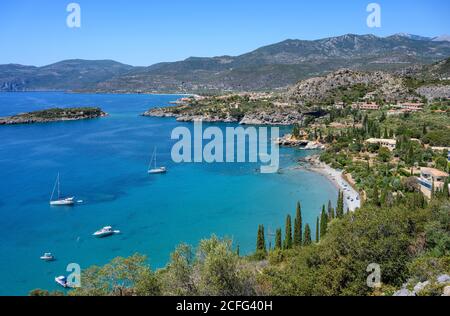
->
xmin=301 ymin=155 xmax=361 ymax=212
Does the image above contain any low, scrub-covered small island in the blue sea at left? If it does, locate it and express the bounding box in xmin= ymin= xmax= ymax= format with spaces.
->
xmin=0 ymin=107 xmax=107 ymax=125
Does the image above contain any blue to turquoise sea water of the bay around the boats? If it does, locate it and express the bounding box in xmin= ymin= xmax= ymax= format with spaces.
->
xmin=0 ymin=93 xmax=337 ymax=295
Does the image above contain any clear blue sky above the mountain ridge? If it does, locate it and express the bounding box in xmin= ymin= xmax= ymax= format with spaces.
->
xmin=0 ymin=0 xmax=450 ymax=66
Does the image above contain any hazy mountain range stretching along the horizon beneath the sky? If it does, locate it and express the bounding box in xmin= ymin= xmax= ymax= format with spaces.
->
xmin=0 ymin=34 xmax=450 ymax=92
